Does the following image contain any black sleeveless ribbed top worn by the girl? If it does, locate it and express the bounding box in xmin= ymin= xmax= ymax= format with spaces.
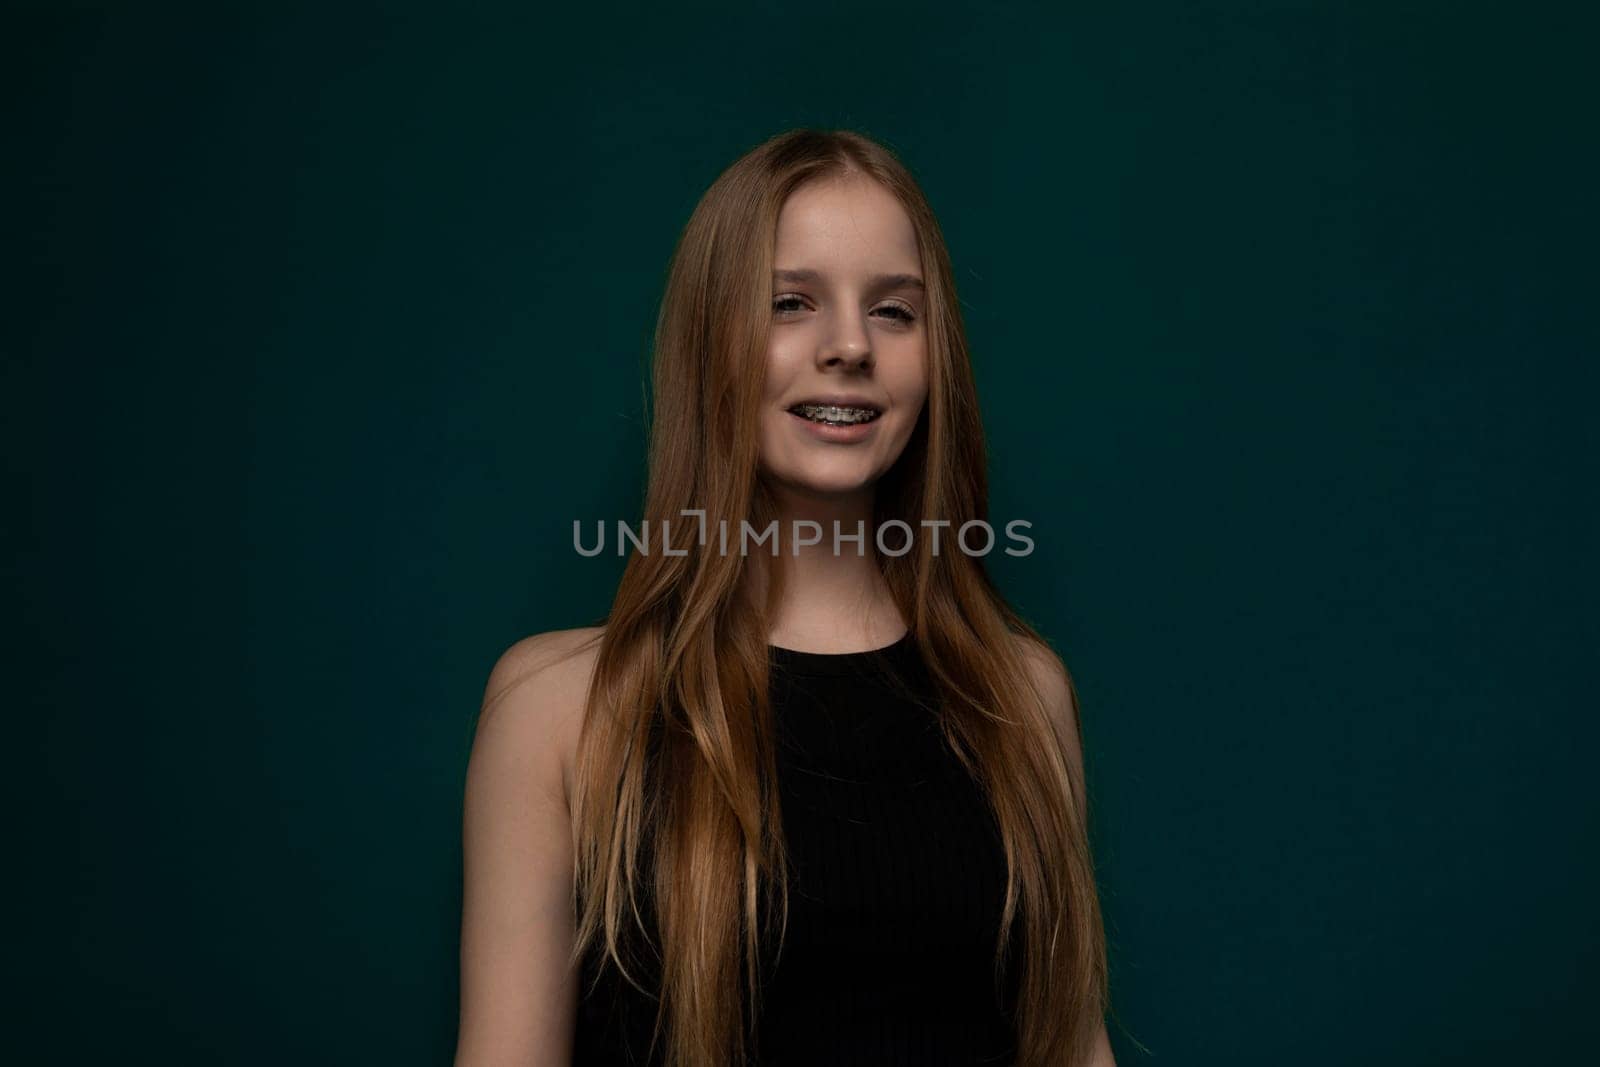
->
xmin=573 ymin=633 xmax=1021 ymax=1067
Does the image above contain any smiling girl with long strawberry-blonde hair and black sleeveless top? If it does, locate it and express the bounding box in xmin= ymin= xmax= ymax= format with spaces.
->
xmin=456 ymin=130 xmax=1112 ymax=1067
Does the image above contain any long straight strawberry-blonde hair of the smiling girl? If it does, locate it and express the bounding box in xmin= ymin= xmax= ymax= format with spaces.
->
xmin=571 ymin=130 xmax=1107 ymax=1067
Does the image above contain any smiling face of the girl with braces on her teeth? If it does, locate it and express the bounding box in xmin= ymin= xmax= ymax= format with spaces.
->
xmin=760 ymin=174 xmax=928 ymax=496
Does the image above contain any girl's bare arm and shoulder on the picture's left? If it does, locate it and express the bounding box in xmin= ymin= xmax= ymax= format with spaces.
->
xmin=456 ymin=630 xmax=594 ymax=1067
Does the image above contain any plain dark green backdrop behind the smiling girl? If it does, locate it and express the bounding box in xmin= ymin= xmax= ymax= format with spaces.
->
xmin=9 ymin=0 xmax=1600 ymax=1065
